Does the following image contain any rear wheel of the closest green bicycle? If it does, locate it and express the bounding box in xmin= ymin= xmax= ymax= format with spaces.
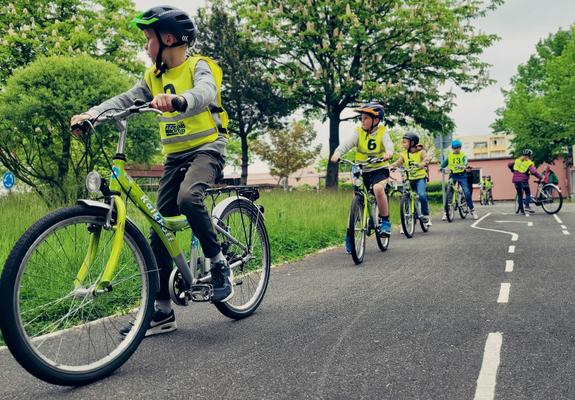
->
xmin=214 ymin=199 xmax=271 ymax=320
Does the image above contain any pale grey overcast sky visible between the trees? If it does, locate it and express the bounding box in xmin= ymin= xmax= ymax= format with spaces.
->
xmin=135 ymin=0 xmax=575 ymax=170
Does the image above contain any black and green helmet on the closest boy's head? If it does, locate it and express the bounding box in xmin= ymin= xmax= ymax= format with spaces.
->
xmin=132 ymin=6 xmax=197 ymax=76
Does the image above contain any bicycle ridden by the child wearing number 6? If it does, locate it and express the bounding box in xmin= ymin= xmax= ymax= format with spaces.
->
xmin=340 ymin=158 xmax=389 ymax=264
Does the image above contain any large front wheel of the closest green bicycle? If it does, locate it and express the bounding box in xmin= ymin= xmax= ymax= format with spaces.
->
xmin=0 ymin=206 xmax=157 ymax=386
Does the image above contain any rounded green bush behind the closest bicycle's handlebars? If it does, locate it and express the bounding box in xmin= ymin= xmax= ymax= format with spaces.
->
xmin=0 ymin=55 xmax=158 ymax=202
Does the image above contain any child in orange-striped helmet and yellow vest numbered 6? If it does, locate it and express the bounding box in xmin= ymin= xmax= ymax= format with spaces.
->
xmin=330 ymin=102 xmax=393 ymax=252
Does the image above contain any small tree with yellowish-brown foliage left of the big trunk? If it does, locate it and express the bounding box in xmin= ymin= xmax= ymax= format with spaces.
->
xmin=253 ymin=121 xmax=321 ymax=185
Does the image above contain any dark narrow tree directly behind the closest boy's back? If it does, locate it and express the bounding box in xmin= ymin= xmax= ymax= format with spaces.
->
xmin=197 ymin=1 xmax=294 ymax=184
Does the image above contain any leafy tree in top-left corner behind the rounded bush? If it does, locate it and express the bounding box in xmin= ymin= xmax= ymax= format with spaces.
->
xmin=0 ymin=0 xmax=144 ymax=86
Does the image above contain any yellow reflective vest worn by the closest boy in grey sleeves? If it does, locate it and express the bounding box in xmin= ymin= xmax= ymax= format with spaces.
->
xmin=144 ymin=55 xmax=228 ymax=154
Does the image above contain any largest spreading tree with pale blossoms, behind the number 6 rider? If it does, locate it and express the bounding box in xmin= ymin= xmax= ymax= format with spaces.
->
xmin=233 ymin=0 xmax=502 ymax=186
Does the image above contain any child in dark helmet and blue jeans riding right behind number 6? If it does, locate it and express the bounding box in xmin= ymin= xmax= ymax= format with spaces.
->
xmin=390 ymin=132 xmax=431 ymax=226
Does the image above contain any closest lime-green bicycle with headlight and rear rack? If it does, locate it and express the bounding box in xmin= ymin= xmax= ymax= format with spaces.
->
xmin=0 ymin=103 xmax=271 ymax=386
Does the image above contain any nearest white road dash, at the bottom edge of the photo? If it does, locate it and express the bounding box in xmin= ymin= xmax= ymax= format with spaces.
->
xmin=473 ymin=332 xmax=503 ymax=400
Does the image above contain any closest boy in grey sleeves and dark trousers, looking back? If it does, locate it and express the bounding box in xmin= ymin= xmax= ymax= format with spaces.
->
xmin=71 ymin=6 xmax=233 ymax=336
